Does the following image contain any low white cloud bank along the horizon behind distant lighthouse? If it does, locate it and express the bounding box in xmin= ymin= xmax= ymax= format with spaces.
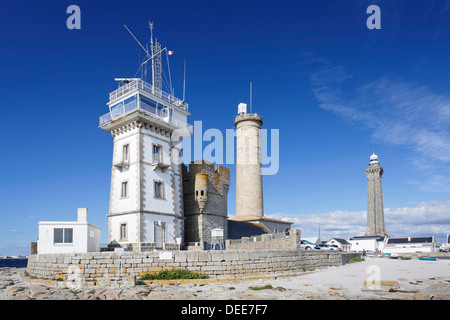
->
xmin=267 ymin=201 xmax=450 ymax=240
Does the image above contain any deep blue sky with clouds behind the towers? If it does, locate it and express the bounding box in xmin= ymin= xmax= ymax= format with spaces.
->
xmin=0 ymin=0 xmax=450 ymax=255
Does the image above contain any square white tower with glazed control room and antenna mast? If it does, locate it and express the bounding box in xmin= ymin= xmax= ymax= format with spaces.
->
xmin=99 ymin=24 xmax=191 ymax=251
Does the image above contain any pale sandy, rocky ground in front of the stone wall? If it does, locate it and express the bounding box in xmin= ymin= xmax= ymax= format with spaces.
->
xmin=0 ymin=257 xmax=450 ymax=300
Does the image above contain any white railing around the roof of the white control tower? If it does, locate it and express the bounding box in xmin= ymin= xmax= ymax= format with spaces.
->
xmin=109 ymin=79 xmax=188 ymax=111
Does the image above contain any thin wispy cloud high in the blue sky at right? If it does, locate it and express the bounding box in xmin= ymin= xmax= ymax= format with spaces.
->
xmin=304 ymin=55 xmax=450 ymax=192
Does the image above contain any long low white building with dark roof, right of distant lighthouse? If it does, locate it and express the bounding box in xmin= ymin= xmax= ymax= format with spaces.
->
xmin=383 ymin=235 xmax=436 ymax=254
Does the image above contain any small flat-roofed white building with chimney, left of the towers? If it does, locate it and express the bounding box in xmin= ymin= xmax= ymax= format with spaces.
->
xmin=37 ymin=208 xmax=100 ymax=254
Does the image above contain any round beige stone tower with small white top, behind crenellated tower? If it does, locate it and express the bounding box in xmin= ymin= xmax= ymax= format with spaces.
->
xmin=234 ymin=104 xmax=264 ymax=220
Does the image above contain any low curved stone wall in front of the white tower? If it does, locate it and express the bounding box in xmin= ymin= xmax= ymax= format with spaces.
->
xmin=27 ymin=250 xmax=360 ymax=283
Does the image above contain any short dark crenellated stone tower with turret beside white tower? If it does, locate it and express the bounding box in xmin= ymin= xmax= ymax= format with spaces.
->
xmin=182 ymin=160 xmax=230 ymax=244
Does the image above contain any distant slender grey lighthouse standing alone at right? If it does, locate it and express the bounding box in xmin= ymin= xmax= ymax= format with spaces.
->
xmin=365 ymin=154 xmax=387 ymax=236
